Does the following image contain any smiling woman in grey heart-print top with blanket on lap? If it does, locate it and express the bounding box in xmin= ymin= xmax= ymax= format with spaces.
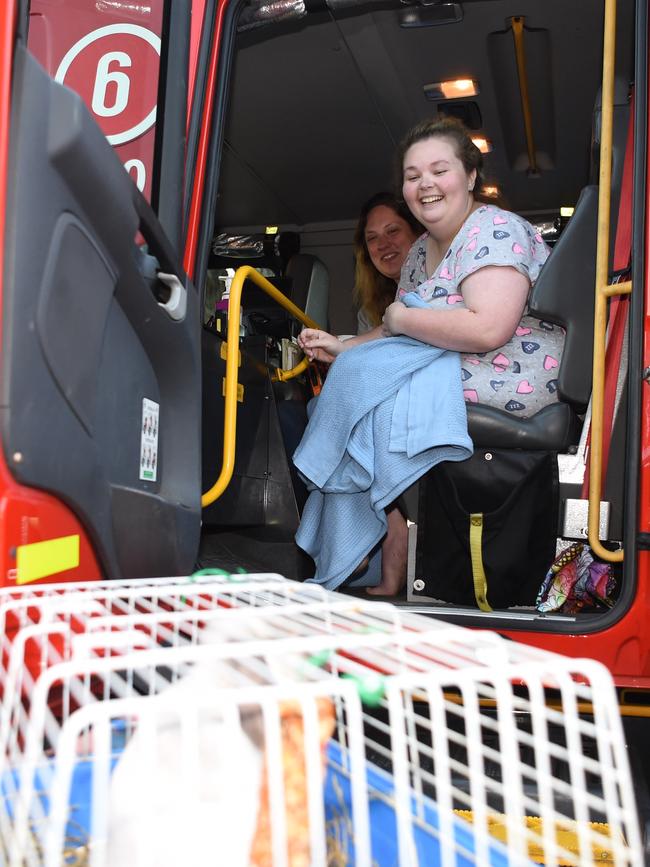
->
xmin=298 ymin=118 xmax=564 ymax=418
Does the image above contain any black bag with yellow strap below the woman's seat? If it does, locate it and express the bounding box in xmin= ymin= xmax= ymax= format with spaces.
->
xmin=413 ymin=449 xmax=558 ymax=611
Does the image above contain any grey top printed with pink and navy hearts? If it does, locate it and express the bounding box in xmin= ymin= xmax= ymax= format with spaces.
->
xmin=397 ymin=205 xmax=564 ymax=418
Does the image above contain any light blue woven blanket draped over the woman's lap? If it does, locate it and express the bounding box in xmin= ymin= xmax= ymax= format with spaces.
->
xmin=293 ymin=337 xmax=472 ymax=590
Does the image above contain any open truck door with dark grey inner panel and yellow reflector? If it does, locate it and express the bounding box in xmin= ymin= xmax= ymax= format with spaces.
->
xmin=0 ymin=2 xmax=200 ymax=583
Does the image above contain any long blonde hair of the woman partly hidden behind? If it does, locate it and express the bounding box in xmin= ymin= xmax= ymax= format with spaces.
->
xmin=353 ymin=193 xmax=424 ymax=326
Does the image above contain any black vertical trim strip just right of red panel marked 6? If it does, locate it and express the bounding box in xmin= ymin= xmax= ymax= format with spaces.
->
xmin=151 ymin=0 xmax=192 ymax=253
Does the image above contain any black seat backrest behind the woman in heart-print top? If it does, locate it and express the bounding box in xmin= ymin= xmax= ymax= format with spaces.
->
xmin=530 ymin=186 xmax=598 ymax=412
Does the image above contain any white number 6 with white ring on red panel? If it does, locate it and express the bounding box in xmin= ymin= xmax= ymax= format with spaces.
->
xmin=54 ymin=24 xmax=160 ymax=145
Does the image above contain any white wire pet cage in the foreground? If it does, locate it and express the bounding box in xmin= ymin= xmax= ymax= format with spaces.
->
xmin=0 ymin=574 xmax=643 ymax=867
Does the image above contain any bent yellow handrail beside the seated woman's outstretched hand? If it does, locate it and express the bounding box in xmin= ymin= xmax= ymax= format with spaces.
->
xmin=201 ymin=265 xmax=318 ymax=508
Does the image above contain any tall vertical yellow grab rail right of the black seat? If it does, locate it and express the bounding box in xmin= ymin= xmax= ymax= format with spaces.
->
xmin=587 ymin=0 xmax=632 ymax=563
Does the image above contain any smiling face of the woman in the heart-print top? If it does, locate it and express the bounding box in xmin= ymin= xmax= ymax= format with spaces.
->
xmin=402 ymin=136 xmax=476 ymax=240
